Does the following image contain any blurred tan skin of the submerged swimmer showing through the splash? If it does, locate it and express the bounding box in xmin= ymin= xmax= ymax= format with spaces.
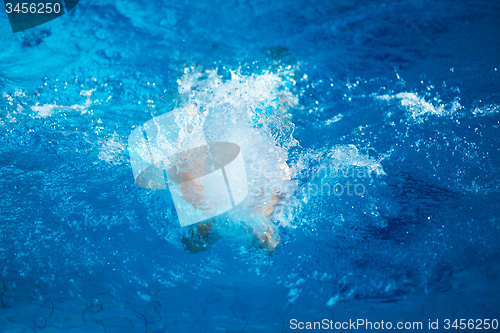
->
xmin=167 ymin=106 xmax=291 ymax=252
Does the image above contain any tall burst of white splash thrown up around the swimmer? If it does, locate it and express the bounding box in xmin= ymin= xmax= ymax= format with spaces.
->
xmin=167 ymin=67 xmax=298 ymax=232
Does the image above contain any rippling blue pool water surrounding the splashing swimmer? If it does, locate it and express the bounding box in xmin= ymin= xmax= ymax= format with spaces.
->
xmin=0 ymin=0 xmax=500 ymax=333
